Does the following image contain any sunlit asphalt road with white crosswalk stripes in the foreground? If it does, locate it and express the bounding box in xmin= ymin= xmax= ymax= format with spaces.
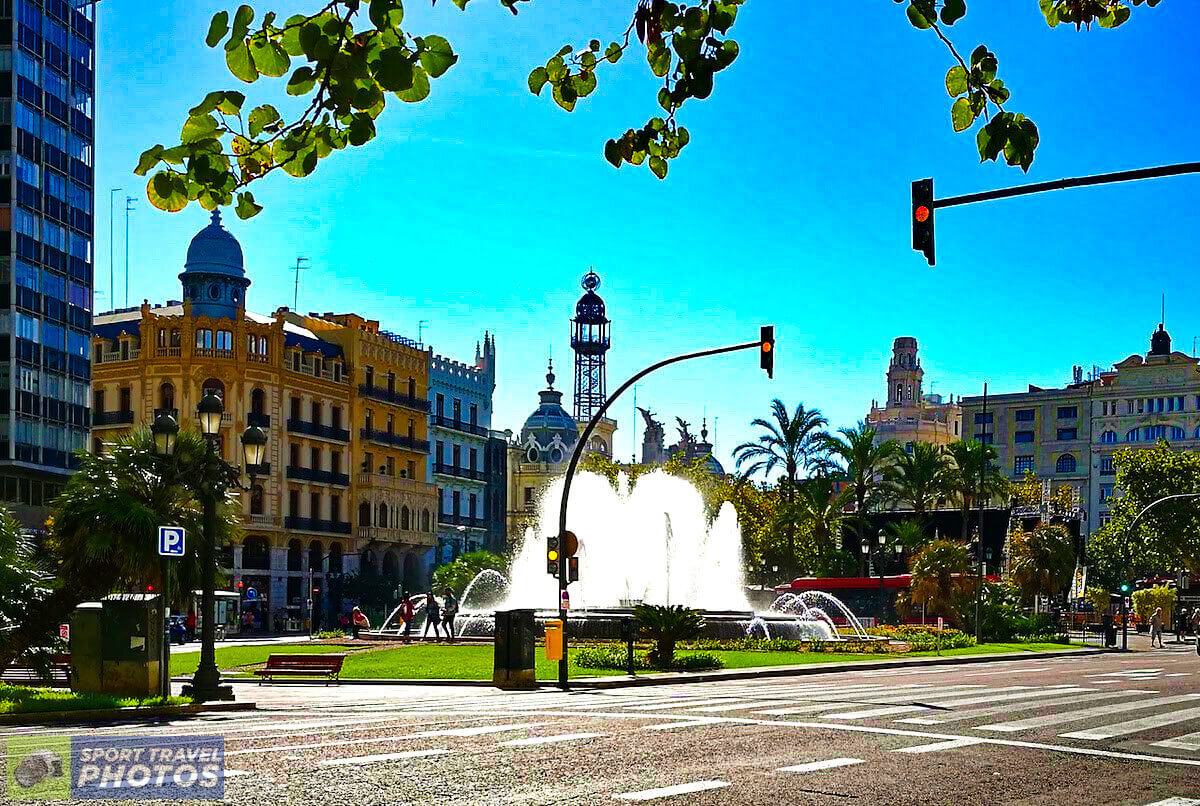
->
xmin=7 ymin=644 xmax=1200 ymax=806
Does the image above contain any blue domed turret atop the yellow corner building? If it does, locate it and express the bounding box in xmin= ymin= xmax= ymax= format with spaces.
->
xmin=179 ymin=210 xmax=250 ymax=319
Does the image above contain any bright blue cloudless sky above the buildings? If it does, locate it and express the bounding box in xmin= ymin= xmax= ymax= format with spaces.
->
xmin=96 ymin=0 xmax=1200 ymax=467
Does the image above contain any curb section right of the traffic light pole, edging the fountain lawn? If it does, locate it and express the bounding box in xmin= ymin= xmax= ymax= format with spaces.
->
xmin=570 ymin=649 xmax=1109 ymax=688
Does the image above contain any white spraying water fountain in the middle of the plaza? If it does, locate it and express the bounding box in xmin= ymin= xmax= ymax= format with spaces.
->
xmin=436 ymin=471 xmax=866 ymax=640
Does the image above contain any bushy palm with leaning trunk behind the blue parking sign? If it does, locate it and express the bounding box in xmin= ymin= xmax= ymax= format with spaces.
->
xmin=0 ymin=428 xmax=241 ymax=669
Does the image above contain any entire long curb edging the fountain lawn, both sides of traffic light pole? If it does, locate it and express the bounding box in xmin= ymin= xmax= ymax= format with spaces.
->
xmin=182 ymin=648 xmax=1120 ymax=688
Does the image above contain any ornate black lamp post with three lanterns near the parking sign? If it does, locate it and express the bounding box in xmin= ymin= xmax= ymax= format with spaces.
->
xmin=150 ymin=389 xmax=266 ymax=702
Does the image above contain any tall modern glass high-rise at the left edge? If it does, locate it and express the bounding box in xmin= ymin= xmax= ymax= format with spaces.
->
xmin=0 ymin=0 xmax=96 ymax=525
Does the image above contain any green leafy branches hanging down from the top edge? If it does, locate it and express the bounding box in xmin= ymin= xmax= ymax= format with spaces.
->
xmin=136 ymin=0 xmax=1160 ymax=218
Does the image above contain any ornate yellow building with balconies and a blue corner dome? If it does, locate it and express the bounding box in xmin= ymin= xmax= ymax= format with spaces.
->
xmin=92 ymin=213 xmax=437 ymax=628
